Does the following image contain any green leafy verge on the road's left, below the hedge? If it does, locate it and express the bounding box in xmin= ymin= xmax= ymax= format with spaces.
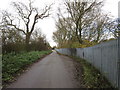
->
xmin=2 ymin=51 xmax=52 ymax=87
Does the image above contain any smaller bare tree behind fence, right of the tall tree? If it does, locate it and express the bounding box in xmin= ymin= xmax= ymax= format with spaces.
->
xmin=84 ymin=12 xmax=110 ymax=43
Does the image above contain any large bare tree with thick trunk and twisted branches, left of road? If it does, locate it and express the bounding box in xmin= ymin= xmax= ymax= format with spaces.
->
xmin=4 ymin=0 xmax=51 ymax=51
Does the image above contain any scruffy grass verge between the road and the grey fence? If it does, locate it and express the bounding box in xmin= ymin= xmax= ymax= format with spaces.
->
xmin=57 ymin=52 xmax=118 ymax=90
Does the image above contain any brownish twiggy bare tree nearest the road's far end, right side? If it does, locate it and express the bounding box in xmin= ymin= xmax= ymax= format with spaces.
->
xmin=53 ymin=17 xmax=75 ymax=48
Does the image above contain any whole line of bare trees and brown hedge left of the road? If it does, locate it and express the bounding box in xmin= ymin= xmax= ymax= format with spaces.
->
xmin=0 ymin=0 xmax=51 ymax=54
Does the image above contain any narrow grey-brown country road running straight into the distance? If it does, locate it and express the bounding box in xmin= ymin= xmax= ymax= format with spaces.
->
xmin=7 ymin=51 xmax=79 ymax=88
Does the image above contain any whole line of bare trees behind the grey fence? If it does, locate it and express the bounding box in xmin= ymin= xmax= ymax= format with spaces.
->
xmin=53 ymin=0 xmax=120 ymax=48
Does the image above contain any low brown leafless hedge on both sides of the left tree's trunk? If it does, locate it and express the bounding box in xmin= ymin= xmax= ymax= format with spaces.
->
xmin=2 ymin=26 xmax=50 ymax=54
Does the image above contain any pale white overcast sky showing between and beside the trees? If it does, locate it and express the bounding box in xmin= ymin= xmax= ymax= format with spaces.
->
xmin=0 ymin=0 xmax=120 ymax=46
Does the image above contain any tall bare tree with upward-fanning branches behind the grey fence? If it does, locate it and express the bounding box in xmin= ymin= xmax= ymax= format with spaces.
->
xmin=65 ymin=0 xmax=102 ymax=44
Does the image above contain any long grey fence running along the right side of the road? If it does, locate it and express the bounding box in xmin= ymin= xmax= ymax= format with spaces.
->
xmin=56 ymin=38 xmax=120 ymax=89
